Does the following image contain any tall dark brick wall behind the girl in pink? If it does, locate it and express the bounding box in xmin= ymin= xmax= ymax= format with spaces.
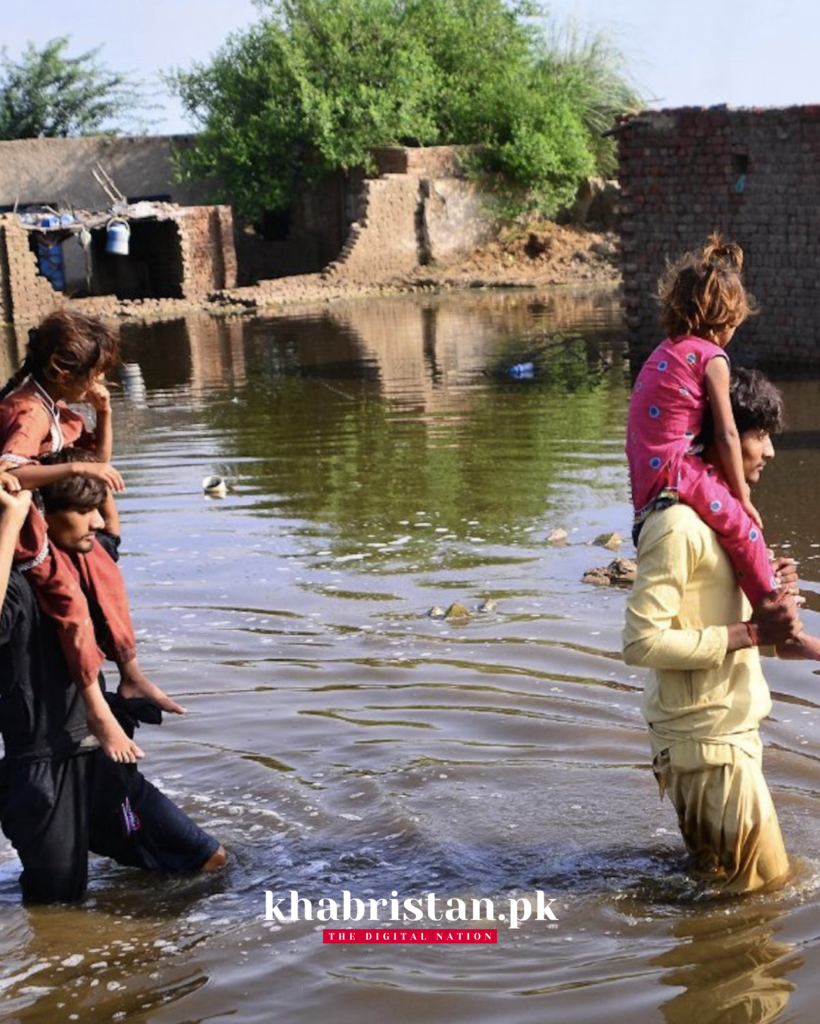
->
xmin=616 ymin=106 xmax=820 ymax=367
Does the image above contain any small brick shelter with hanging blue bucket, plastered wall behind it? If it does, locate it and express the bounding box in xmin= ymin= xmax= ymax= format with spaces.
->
xmin=0 ymin=137 xmax=236 ymax=323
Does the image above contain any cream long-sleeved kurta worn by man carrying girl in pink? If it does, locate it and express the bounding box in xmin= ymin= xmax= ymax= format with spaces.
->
xmin=623 ymin=505 xmax=772 ymax=770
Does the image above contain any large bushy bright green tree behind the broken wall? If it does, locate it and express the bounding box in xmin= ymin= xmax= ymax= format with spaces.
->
xmin=169 ymin=0 xmax=638 ymax=219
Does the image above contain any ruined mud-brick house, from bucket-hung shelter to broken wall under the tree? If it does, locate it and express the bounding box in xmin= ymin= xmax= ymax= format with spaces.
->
xmin=0 ymin=136 xmax=501 ymax=323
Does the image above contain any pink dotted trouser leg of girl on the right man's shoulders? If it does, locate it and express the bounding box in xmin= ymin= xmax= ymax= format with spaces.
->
xmin=678 ymin=456 xmax=777 ymax=607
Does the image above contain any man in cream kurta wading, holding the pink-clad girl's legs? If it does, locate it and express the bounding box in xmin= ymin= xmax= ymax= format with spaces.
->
xmin=623 ymin=370 xmax=820 ymax=893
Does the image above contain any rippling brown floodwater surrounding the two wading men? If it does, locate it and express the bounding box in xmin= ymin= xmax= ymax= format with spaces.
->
xmin=0 ymin=291 xmax=820 ymax=1024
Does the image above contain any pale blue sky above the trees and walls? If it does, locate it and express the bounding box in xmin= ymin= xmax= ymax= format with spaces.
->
xmin=0 ymin=0 xmax=820 ymax=133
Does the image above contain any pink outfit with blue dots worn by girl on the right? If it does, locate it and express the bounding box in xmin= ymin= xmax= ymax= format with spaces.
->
xmin=627 ymin=337 xmax=777 ymax=605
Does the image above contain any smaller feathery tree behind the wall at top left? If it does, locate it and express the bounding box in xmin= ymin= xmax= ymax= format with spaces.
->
xmin=0 ymin=36 xmax=146 ymax=139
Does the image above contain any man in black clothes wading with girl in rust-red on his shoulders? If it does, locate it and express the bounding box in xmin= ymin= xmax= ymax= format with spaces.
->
xmin=0 ymin=450 xmax=226 ymax=903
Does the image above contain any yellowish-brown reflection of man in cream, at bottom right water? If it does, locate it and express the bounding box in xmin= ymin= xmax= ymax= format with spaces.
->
xmin=652 ymin=904 xmax=804 ymax=1024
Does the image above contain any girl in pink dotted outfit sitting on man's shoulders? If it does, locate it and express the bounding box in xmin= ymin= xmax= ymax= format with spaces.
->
xmin=627 ymin=234 xmax=776 ymax=605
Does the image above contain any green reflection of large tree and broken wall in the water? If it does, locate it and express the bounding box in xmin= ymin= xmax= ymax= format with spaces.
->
xmin=202 ymin=305 xmax=625 ymax=543
